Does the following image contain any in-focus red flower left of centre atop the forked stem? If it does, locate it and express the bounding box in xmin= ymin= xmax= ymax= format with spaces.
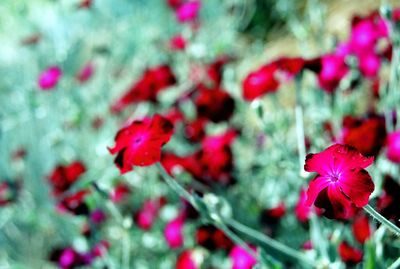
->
xmin=109 ymin=114 xmax=173 ymax=174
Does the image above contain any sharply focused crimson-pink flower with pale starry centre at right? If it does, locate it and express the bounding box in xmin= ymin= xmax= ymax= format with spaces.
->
xmin=304 ymin=144 xmax=374 ymax=219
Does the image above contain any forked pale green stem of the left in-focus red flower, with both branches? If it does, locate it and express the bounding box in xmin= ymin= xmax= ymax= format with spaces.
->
xmin=156 ymin=163 xmax=313 ymax=267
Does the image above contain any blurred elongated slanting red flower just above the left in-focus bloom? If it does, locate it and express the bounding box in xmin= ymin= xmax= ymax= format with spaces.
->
xmin=111 ymin=65 xmax=176 ymax=113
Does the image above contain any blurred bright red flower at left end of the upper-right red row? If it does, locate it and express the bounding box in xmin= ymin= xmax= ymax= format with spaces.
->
xmin=243 ymin=65 xmax=279 ymax=101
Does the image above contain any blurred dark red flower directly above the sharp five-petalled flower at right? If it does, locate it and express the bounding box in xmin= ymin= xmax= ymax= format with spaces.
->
xmin=342 ymin=116 xmax=386 ymax=156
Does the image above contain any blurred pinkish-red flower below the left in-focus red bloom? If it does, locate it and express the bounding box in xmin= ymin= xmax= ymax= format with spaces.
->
xmin=135 ymin=197 xmax=166 ymax=230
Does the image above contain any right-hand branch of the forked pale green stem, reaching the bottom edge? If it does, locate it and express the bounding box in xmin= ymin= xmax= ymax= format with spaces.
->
xmin=228 ymin=219 xmax=314 ymax=267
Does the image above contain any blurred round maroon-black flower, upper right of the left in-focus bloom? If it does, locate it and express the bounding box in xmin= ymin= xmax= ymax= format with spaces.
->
xmin=194 ymin=85 xmax=235 ymax=123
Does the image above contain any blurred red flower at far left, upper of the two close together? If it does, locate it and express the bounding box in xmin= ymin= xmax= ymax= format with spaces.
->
xmin=48 ymin=161 xmax=86 ymax=195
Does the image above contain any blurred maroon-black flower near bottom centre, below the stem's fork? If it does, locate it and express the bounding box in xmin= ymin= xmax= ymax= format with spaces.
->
xmin=196 ymin=225 xmax=233 ymax=251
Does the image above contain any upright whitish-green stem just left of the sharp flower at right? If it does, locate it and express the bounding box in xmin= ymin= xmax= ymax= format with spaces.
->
xmin=295 ymin=73 xmax=306 ymax=177
